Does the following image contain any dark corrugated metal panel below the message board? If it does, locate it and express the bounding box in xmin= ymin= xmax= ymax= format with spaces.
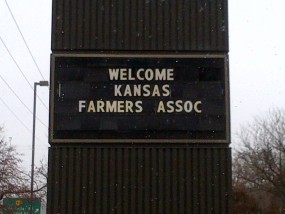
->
xmin=45 ymin=145 xmax=231 ymax=214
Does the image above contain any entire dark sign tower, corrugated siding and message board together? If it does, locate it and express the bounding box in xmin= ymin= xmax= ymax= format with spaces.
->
xmin=47 ymin=0 xmax=232 ymax=214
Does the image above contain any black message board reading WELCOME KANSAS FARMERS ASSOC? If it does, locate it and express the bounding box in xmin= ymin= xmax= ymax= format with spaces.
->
xmin=50 ymin=54 xmax=228 ymax=142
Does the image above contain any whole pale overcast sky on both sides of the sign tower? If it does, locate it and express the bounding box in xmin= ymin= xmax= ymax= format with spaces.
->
xmin=0 ymin=0 xmax=285 ymax=168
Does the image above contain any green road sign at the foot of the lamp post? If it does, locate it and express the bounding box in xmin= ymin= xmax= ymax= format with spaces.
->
xmin=3 ymin=198 xmax=41 ymax=214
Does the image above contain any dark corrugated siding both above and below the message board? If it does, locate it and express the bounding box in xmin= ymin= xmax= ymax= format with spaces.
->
xmin=47 ymin=0 xmax=232 ymax=214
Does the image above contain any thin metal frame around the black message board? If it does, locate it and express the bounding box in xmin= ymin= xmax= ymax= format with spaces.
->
xmin=49 ymin=53 xmax=230 ymax=143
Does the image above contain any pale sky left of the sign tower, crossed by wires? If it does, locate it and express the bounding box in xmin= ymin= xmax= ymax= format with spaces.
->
xmin=0 ymin=0 xmax=51 ymax=169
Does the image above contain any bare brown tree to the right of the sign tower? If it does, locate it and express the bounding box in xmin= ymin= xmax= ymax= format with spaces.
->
xmin=233 ymin=109 xmax=285 ymax=213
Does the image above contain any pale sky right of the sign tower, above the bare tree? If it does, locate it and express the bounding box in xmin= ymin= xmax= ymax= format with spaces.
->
xmin=229 ymin=0 xmax=285 ymax=135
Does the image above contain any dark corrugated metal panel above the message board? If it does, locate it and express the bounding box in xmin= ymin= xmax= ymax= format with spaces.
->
xmin=52 ymin=0 xmax=228 ymax=52
